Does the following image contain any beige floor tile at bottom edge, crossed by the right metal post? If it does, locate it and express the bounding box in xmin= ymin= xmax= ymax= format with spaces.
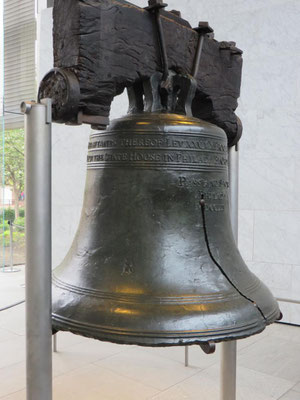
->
xmin=153 ymin=372 xmax=274 ymax=400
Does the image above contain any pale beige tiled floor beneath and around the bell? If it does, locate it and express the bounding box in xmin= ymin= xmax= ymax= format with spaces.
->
xmin=0 ymin=269 xmax=300 ymax=400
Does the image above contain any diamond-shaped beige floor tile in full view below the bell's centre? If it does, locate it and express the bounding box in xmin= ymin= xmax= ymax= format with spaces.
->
xmin=97 ymin=347 xmax=198 ymax=390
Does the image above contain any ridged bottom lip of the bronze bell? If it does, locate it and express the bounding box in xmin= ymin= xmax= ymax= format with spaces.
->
xmin=52 ymin=310 xmax=278 ymax=347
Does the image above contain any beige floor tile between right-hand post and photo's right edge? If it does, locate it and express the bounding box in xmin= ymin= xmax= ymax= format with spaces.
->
xmin=238 ymin=336 xmax=300 ymax=383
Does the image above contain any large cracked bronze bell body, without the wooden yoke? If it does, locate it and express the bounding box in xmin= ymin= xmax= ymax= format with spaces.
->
xmin=53 ymin=75 xmax=280 ymax=346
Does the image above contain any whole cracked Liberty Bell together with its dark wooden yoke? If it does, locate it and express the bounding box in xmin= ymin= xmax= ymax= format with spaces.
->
xmin=39 ymin=0 xmax=281 ymax=346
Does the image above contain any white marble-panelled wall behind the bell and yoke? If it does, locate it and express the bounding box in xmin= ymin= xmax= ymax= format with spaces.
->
xmin=40 ymin=0 xmax=300 ymax=323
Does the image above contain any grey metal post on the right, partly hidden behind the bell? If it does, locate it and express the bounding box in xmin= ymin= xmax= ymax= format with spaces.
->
xmin=220 ymin=145 xmax=239 ymax=400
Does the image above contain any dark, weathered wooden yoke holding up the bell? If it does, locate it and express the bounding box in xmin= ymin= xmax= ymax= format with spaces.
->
xmin=39 ymin=0 xmax=242 ymax=145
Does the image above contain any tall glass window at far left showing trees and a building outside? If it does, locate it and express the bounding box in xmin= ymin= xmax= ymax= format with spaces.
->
xmin=0 ymin=0 xmax=37 ymax=270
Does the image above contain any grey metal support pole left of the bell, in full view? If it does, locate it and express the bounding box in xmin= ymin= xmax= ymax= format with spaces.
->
xmin=21 ymin=99 xmax=52 ymax=400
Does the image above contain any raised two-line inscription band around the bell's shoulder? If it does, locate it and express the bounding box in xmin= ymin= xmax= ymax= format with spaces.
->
xmin=87 ymin=132 xmax=227 ymax=169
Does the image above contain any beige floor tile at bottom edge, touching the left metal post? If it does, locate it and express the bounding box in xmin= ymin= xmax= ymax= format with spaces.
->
xmin=53 ymin=365 xmax=158 ymax=400
